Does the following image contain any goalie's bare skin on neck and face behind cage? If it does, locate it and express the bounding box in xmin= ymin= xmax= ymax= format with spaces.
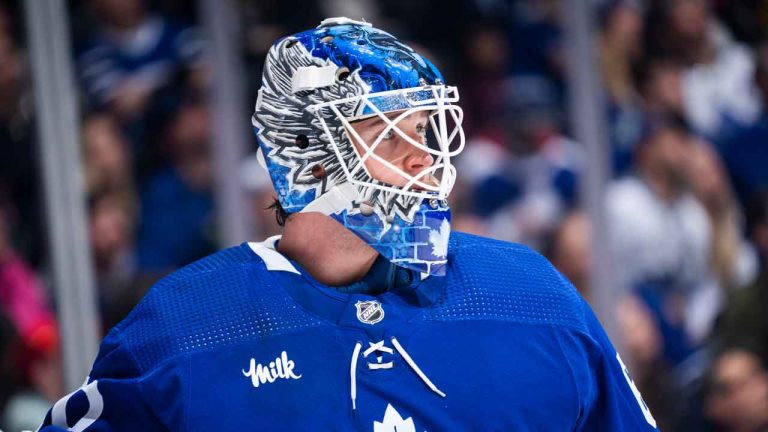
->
xmin=277 ymin=111 xmax=433 ymax=286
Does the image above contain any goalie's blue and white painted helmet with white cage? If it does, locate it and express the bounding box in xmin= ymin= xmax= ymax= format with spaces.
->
xmin=253 ymin=18 xmax=464 ymax=275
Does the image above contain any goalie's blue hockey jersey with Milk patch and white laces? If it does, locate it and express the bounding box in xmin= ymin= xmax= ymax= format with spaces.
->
xmin=43 ymin=233 xmax=656 ymax=432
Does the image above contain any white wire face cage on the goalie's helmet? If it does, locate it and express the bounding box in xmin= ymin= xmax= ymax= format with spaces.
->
xmin=308 ymin=85 xmax=465 ymax=220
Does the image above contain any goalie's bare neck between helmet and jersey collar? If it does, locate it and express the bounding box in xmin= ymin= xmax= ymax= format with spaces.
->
xmin=277 ymin=213 xmax=378 ymax=286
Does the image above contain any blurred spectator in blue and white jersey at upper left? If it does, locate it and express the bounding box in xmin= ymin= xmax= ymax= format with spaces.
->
xmin=77 ymin=0 xmax=207 ymax=173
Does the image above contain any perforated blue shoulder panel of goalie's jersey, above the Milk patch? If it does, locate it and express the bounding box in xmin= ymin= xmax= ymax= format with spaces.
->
xmin=119 ymin=244 xmax=321 ymax=370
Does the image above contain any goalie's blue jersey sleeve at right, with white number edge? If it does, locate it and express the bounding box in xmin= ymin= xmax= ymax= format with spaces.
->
xmin=560 ymin=301 xmax=658 ymax=432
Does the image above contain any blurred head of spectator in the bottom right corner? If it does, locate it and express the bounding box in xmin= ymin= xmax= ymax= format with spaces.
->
xmin=704 ymin=348 xmax=768 ymax=432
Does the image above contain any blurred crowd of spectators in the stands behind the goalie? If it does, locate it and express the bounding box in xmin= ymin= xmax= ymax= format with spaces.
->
xmin=0 ymin=0 xmax=768 ymax=432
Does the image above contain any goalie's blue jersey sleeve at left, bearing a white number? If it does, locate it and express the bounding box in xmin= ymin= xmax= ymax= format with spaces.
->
xmin=39 ymin=329 xmax=186 ymax=432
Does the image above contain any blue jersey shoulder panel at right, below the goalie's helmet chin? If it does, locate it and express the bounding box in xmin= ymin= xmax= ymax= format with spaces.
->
xmin=428 ymin=233 xmax=586 ymax=331
